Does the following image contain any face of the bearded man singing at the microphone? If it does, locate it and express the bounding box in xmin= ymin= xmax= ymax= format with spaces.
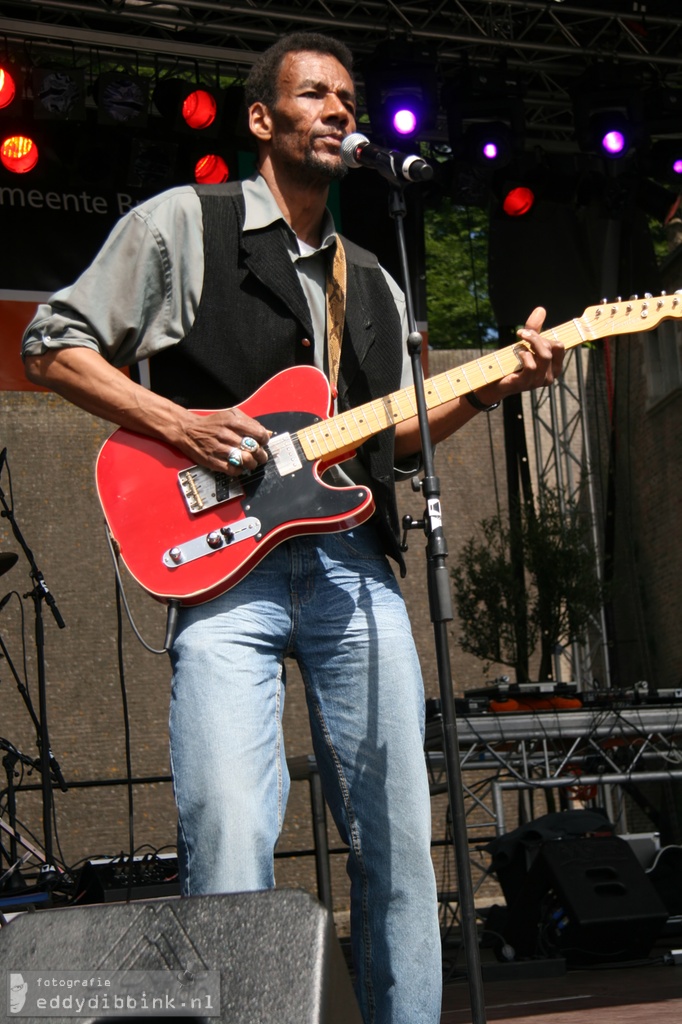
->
xmin=270 ymin=51 xmax=355 ymax=181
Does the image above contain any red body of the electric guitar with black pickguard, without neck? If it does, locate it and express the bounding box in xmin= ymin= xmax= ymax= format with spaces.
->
xmin=97 ymin=387 xmax=374 ymax=604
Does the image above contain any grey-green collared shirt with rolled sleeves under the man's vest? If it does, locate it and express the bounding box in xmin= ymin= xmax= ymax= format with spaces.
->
xmin=22 ymin=175 xmax=412 ymax=387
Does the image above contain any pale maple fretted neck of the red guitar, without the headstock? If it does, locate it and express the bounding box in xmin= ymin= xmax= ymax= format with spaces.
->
xmin=297 ymin=319 xmax=593 ymax=461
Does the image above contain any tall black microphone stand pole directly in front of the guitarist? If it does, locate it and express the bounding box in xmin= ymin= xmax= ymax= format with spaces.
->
xmin=386 ymin=175 xmax=485 ymax=1024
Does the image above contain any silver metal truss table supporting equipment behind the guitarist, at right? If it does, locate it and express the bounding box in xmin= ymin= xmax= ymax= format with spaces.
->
xmin=426 ymin=700 xmax=682 ymax=903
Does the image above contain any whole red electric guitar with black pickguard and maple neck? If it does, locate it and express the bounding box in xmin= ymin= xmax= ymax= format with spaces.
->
xmin=96 ymin=294 xmax=682 ymax=604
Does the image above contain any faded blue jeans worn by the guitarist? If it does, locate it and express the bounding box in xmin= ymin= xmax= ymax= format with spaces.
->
xmin=170 ymin=525 xmax=441 ymax=1024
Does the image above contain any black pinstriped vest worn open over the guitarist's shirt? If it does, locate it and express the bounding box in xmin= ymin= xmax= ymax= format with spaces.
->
xmin=151 ymin=182 xmax=402 ymax=567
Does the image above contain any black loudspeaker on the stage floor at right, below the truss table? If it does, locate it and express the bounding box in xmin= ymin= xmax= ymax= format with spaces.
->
xmin=504 ymin=837 xmax=668 ymax=965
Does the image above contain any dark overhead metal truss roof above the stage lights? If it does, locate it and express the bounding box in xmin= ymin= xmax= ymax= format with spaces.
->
xmin=0 ymin=0 xmax=682 ymax=144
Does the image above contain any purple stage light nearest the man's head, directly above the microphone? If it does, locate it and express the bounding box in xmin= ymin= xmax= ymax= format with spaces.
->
xmin=364 ymin=41 xmax=437 ymax=143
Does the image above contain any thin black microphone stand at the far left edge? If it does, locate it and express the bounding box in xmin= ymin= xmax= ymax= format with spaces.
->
xmin=0 ymin=460 xmax=68 ymax=887
